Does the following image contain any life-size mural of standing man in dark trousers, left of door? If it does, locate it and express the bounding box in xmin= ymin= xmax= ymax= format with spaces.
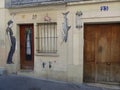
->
xmin=6 ymin=20 xmax=16 ymax=64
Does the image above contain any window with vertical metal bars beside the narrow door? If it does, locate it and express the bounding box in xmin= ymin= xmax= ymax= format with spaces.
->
xmin=36 ymin=23 xmax=57 ymax=53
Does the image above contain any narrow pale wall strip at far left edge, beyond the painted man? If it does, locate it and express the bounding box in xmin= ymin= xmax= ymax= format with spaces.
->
xmin=0 ymin=0 xmax=6 ymax=68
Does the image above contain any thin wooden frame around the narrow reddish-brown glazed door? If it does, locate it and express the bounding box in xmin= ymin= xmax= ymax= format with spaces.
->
xmin=18 ymin=23 xmax=35 ymax=70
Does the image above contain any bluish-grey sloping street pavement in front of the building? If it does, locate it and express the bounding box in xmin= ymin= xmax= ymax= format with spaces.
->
xmin=0 ymin=75 xmax=120 ymax=90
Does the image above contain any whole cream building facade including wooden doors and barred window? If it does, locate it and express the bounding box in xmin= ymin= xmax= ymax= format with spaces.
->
xmin=0 ymin=0 xmax=120 ymax=83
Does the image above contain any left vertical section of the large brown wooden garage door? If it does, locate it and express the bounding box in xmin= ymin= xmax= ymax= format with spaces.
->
xmin=84 ymin=26 xmax=95 ymax=82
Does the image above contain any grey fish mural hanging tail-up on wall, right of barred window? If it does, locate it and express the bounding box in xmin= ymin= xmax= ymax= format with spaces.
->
xmin=62 ymin=11 xmax=71 ymax=42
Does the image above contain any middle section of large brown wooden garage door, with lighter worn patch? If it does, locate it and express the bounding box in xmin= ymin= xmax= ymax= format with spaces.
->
xmin=95 ymin=25 xmax=111 ymax=82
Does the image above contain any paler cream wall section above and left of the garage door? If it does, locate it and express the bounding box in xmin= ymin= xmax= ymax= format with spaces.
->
xmin=67 ymin=2 xmax=120 ymax=82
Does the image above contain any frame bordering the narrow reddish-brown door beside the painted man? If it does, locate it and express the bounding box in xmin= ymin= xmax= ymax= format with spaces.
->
xmin=17 ymin=23 xmax=35 ymax=70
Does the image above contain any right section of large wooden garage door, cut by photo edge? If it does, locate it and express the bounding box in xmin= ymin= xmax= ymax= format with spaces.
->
xmin=110 ymin=24 xmax=120 ymax=82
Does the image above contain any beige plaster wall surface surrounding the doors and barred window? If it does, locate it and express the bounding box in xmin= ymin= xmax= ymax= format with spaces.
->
xmin=2 ymin=2 xmax=120 ymax=83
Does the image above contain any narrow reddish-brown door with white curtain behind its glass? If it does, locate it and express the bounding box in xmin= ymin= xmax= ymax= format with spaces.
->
xmin=20 ymin=24 xmax=34 ymax=69
